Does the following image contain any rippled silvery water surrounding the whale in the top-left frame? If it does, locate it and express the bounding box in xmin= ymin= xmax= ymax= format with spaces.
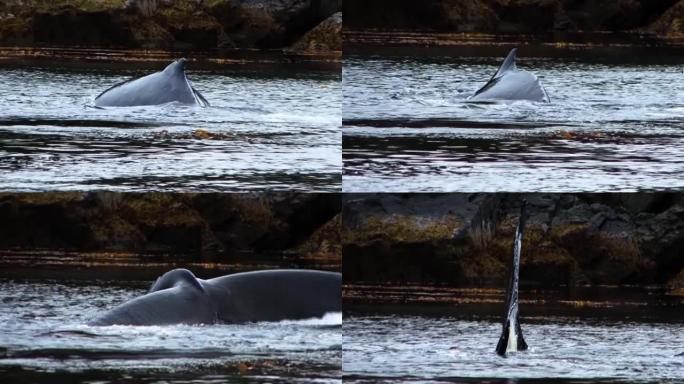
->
xmin=0 ymin=63 xmax=341 ymax=191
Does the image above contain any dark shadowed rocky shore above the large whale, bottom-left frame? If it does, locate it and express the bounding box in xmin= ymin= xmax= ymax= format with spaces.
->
xmin=0 ymin=192 xmax=341 ymax=270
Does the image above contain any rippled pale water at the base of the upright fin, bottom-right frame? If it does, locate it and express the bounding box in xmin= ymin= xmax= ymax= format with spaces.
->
xmin=342 ymin=310 xmax=684 ymax=383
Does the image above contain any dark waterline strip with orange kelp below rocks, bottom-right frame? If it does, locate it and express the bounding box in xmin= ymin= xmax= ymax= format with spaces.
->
xmin=342 ymin=283 xmax=684 ymax=316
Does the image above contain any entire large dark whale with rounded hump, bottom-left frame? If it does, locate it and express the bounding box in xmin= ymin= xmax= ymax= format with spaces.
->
xmin=88 ymin=268 xmax=342 ymax=326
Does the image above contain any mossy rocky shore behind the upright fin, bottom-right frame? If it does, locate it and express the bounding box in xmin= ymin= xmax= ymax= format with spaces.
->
xmin=342 ymin=194 xmax=684 ymax=294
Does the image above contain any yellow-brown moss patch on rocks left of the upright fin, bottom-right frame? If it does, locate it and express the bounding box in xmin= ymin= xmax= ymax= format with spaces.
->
xmin=343 ymin=215 xmax=461 ymax=244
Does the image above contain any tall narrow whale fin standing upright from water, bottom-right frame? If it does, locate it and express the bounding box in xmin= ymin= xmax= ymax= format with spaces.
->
xmin=496 ymin=200 xmax=527 ymax=356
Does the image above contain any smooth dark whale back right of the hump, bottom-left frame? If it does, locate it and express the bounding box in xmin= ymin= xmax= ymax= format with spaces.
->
xmin=204 ymin=270 xmax=342 ymax=323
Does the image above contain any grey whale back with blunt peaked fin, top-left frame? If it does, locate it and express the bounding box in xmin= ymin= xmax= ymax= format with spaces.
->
xmin=95 ymin=59 xmax=209 ymax=107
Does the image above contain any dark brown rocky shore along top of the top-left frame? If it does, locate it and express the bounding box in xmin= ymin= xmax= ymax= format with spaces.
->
xmin=0 ymin=0 xmax=342 ymax=53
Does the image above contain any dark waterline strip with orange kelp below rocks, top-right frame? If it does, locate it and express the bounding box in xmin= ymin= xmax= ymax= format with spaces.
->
xmin=343 ymin=29 xmax=684 ymax=63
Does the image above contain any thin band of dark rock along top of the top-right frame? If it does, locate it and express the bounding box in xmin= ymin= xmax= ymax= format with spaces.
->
xmin=344 ymin=0 xmax=682 ymax=38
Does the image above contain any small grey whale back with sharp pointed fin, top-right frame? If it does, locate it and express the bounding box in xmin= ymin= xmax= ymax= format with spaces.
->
xmin=468 ymin=48 xmax=549 ymax=103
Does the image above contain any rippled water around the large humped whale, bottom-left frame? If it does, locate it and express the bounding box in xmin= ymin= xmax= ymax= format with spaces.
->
xmin=0 ymin=279 xmax=342 ymax=383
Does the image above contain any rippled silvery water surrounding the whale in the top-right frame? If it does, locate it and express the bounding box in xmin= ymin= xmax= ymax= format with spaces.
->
xmin=343 ymin=54 xmax=684 ymax=192
